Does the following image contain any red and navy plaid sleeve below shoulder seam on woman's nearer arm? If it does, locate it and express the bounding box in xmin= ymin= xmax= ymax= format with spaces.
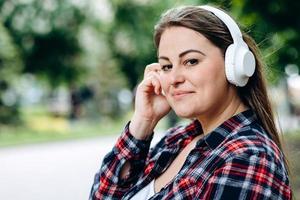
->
xmin=201 ymin=154 xmax=292 ymax=200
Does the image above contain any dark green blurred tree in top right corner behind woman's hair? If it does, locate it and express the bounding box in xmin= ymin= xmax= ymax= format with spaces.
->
xmin=231 ymin=0 xmax=300 ymax=83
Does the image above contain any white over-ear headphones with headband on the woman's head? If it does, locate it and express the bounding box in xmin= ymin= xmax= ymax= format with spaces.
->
xmin=199 ymin=5 xmax=255 ymax=87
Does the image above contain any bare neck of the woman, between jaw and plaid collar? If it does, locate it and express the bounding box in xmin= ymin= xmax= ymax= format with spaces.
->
xmin=197 ymin=90 xmax=248 ymax=134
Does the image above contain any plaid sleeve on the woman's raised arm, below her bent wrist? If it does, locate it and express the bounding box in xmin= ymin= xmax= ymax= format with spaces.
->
xmin=89 ymin=123 xmax=153 ymax=200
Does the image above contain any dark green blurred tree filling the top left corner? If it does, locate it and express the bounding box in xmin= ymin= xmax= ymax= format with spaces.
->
xmin=0 ymin=0 xmax=85 ymax=88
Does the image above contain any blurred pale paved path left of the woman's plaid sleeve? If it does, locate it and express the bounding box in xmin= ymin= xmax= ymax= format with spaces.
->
xmin=0 ymin=135 xmax=117 ymax=200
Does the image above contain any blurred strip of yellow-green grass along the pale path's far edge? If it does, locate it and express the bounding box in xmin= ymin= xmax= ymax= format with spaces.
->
xmin=0 ymin=107 xmax=129 ymax=147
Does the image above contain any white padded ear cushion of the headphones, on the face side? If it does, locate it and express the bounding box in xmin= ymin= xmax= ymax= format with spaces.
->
xmin=225 ymin=44 xmax=237 ymax=85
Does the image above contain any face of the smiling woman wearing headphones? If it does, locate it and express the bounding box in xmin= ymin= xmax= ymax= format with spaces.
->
xmin=158 ymin=27 xmax=232 ymax=118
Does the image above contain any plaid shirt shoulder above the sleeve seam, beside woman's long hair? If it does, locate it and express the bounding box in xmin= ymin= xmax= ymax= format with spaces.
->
xmin=221 ymin=123 xmax=287 ymax=176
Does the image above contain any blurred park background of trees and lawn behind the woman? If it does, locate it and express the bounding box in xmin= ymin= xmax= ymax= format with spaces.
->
xmin=0 ymin=0 xmax=300 ymax=199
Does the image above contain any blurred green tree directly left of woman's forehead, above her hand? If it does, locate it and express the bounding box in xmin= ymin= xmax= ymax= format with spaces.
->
xmin=108 ymin=0 xmax=168 ymax=88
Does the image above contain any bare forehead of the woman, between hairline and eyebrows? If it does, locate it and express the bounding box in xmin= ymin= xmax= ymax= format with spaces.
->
xmin=158 ymin=26 xmax=213 ymax=56
